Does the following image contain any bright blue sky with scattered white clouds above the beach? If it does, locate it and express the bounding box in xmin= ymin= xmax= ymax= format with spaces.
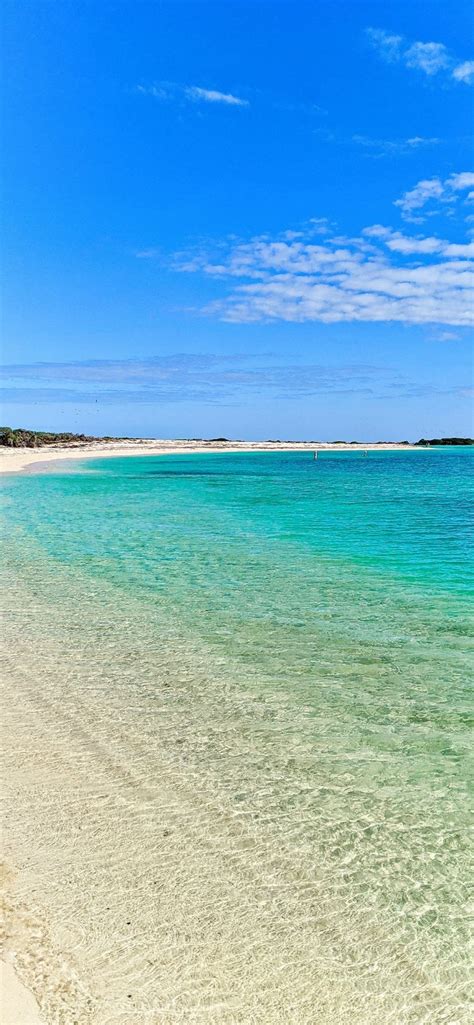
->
xmin=2 ymin=0 xmax=474 ymax=440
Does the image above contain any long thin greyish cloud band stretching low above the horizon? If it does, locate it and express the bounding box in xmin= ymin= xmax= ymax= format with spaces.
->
xmin=2 ymin=353 xmax=459 ymax=406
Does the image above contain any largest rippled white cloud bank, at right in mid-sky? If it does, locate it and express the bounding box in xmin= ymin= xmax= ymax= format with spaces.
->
xmin=177 ymin=224 xmax=474 ymax=325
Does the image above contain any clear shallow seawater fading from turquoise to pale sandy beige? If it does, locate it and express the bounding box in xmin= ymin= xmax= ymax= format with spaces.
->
xmin=3 ymin=449 xmax=474 ymax=1025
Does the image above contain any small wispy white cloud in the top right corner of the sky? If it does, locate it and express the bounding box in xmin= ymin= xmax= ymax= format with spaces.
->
xmin=366 ymin=28 xmax=474 ymax=85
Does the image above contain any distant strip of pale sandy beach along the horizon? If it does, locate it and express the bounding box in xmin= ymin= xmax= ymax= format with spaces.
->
xmin=0 ymin=439 xmax=419 ymax=474
